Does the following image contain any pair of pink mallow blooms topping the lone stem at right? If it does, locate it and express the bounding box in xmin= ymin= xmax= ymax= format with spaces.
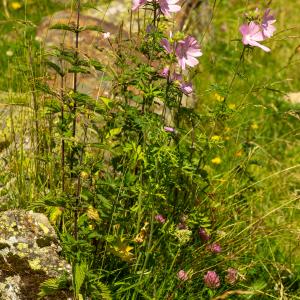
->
xmin=240 ymin=9 xmax=276 ymax=52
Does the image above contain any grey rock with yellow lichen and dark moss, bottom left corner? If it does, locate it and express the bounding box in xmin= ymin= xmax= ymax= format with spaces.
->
xmin=0 ymin=210 xmax=71 ymax=300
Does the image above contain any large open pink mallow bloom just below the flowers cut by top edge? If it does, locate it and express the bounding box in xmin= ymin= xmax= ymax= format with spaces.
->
xmin=175 ymin=36 xmax=202 ymax=70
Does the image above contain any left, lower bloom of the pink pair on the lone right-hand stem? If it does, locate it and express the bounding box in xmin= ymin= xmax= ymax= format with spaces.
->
xmin=240 ymin=21 xmax=271 ymax=52
